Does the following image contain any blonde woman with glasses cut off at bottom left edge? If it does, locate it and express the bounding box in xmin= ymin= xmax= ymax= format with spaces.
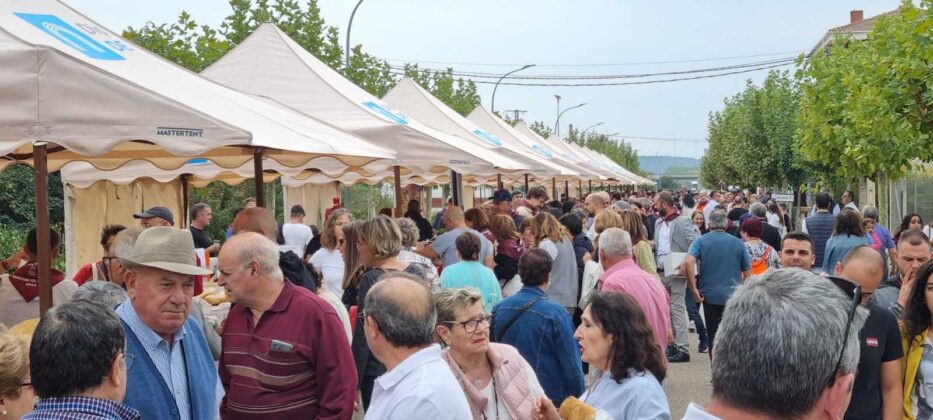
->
xmin=0 ymin=325 xmax=36 ymax=420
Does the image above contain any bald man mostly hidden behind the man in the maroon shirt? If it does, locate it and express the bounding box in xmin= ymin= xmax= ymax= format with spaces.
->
xmin=231 ymin=207 xmax=320 ymax=294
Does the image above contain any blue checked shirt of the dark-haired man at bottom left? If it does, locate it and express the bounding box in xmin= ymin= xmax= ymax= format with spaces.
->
xmin=23 ymin=397 xmax=140 ymax=420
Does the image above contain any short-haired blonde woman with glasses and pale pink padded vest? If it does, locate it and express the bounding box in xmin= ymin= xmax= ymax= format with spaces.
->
xmin=434 ymin=288 xmax=544 ymax=419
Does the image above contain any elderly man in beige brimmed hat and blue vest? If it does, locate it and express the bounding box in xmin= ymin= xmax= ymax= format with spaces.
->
xmin=116 ymin=227 xmax=223 ymax=420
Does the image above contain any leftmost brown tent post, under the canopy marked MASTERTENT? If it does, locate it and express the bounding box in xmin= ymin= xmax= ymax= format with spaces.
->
xmin=32 ymin=142 xmax=53 ymax=317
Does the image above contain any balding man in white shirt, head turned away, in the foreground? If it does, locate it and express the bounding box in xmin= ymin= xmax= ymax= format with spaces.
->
xmin=363 ymin=272 xmax=473 ymax=420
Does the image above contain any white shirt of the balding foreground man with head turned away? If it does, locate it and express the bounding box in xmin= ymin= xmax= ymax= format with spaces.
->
xmin=366 ymin=344 xmax=473 ymax=420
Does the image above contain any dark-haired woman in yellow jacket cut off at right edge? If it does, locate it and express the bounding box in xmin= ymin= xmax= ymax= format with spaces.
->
xmin=901 ymin=260 xmax=933 ymax=419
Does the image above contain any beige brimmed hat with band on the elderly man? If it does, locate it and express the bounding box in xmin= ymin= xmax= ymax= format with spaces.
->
xmin=126 ymin=226 xmax=213 ymax=276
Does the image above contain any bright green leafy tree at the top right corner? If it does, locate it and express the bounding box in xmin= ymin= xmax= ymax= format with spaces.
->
xmin=797 ymin=0 xmax=933 ymax=180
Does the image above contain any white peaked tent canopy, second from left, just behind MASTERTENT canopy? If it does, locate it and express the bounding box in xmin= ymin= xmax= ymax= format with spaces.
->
xmin=201 ymin=24 xmax=527 ymax=207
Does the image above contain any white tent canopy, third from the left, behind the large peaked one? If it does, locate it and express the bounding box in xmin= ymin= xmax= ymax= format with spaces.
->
xmin=382 ymin=78 xmax=579 ymax=184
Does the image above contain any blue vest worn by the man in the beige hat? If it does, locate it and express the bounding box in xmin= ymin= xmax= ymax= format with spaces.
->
xmin=120 ymin=317 xmax=219 ymax=420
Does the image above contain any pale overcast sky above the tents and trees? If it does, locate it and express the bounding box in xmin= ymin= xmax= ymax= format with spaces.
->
xmin=65 ymin=0 xmax=899 ymax=157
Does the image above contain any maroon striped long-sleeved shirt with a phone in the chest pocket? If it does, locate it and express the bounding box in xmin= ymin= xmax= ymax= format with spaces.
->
xmin=219 ymin=281 xmax=357 ymax=419
